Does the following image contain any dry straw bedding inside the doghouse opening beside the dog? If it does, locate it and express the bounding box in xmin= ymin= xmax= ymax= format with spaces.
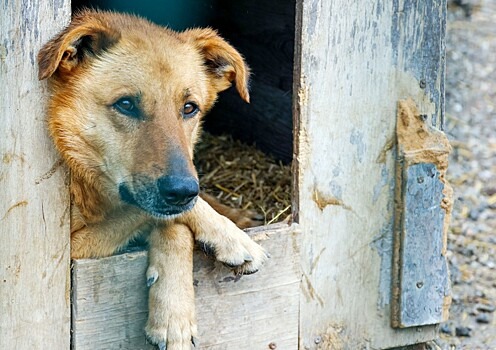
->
xmin=195 ymin=133 xmax=291 ymax=224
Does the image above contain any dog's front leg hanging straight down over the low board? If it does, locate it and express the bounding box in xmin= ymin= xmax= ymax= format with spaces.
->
xmin=145 ymin=223 xmax=197 ymax=350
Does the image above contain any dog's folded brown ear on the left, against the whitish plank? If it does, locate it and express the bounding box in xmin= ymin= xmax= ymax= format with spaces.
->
xmin=38 ymin=11 xmax=120 ymax=80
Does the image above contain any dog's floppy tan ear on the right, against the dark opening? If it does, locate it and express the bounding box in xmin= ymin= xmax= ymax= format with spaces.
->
xmin=182 ymin=28 xmax=250 ymax=102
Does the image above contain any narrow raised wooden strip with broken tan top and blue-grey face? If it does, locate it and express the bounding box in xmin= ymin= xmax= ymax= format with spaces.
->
xmin=392 ymin=100 xmax=453 ymax=327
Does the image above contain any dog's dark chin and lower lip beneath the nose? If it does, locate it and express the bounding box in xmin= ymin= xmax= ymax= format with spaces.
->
xmin=119 ymin=186 xmax=198 ymax=220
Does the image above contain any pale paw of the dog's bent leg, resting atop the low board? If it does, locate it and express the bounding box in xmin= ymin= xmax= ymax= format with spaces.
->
xmin=199 ymin=229 xmax=269 ymax=275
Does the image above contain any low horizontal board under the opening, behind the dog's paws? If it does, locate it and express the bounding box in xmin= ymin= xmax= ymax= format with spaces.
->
xmin=72 ymin=225 xmax=300 ymax=350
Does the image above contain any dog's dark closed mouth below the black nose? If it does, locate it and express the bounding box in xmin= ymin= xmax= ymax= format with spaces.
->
xmin=119 ymin=183 xmax=198 ymax=219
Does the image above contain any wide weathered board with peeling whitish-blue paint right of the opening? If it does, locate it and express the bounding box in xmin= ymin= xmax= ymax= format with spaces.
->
xmin=294 ymin=0 xmax=445 ymax=349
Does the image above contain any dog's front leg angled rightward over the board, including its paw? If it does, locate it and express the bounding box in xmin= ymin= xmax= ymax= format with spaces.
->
xmin=176 ymin=198 xmax=268 ymax=274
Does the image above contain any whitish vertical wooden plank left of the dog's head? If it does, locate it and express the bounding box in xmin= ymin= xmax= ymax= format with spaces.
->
xmin=0 ymin=0 xmax=70 ymax=350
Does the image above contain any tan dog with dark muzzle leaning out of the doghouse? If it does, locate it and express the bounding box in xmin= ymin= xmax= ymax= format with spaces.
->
xmin=38 ymin=10 xmax=268 ymax=350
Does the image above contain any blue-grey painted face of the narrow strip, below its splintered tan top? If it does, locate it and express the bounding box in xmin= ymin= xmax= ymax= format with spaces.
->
xmin=398 ymin=163 xmax=449 ymax=327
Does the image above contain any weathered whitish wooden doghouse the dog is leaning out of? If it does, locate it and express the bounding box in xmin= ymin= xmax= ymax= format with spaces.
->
xmin=0 ymin=0 xmax=449 ymax=350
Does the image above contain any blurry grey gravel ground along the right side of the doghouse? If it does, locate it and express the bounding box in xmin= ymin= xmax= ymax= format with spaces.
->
xmin=437 ymin=0 xmax=496 ymax=350
